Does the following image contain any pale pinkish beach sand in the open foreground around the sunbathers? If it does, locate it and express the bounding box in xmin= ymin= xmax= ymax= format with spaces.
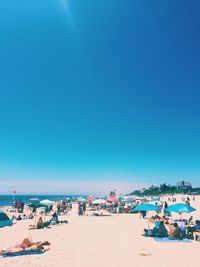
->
xmin=0 ymin=197 xmax=200 ymax=267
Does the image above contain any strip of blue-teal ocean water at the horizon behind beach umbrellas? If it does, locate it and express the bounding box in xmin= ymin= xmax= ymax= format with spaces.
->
xmin=0 ymin=195 xmax=87 ymax=206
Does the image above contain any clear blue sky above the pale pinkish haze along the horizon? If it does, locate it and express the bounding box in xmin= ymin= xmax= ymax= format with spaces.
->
xmin=0 ymin=0 xmax=200 ymax=195
